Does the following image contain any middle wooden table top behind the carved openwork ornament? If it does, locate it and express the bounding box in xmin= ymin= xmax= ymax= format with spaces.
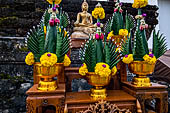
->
xmin=65 ymin=90 xmax=136 ymax=113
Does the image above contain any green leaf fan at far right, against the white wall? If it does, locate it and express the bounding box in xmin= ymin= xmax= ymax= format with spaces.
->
xmin=152 ymin=30 xmax=167 ymax=58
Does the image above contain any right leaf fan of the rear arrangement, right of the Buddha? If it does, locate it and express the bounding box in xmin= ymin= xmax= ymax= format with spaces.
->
xmin=126 ymin=12 xmax=136 ymax=33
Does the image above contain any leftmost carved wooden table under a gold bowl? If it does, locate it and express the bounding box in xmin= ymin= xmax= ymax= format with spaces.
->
xmin=26 ymin=84 xmax=65 ymax=113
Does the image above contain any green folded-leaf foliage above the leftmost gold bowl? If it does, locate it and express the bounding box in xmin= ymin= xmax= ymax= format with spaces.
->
xmin=27 ymin=6 xmax=70 ymax=63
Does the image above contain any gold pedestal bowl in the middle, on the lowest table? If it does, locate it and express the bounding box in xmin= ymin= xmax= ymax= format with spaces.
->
xmin=86 ymin=72 xmax=111 ymax=100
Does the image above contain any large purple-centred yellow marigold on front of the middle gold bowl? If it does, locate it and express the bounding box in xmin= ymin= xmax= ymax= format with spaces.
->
xmin=95 ymin=62 xmax=111 ymax=77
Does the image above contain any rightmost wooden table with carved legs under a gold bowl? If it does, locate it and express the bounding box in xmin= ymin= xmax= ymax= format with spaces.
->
xmin=123 ymin=82 xmax=168 ymax=113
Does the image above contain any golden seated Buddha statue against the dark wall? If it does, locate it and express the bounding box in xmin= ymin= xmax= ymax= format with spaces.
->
xmin=71 ymin=0 xmax=96 ymax=38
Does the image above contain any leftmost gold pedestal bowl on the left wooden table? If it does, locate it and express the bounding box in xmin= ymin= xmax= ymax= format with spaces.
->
xmin=34 ymin=63 xmax=64 ymax=91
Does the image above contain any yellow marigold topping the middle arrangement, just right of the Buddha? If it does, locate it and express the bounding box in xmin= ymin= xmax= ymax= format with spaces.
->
xmin=92 ymin=7 xmax=105 ymax=19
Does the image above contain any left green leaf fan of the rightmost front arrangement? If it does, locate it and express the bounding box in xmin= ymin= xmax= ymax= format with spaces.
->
xmin=121 ymin=32 xmax=132 ymax=56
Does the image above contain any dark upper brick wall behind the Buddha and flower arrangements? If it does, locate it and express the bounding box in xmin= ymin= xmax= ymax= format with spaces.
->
xmin=0 ymin=0 xmax=158 ymax=37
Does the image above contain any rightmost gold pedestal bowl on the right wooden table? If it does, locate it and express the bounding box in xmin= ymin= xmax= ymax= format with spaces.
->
xmin=128 ymin=61 xmax=155 ymax=87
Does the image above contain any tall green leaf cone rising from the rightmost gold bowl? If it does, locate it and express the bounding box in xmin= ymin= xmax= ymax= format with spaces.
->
xmin=133 ymin=30 xmax=146 ymax=61
